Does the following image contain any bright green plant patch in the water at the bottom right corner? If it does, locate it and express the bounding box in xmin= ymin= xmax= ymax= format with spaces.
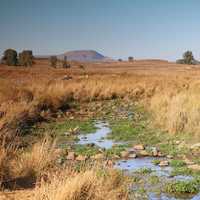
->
xmin=165 ymin=181 xmax=199 ymax=194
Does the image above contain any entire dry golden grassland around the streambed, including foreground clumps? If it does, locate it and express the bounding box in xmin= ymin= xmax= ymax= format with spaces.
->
xmin=0 ymin=60 xmax=200 ymax=200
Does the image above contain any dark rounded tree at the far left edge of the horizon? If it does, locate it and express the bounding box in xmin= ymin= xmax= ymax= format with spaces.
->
xmin=1 ymin=49 xmax=17 ymax=66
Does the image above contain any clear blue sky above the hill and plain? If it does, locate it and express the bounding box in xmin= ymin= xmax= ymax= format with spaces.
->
xmin=0 ymin=0 xmax=200 ymax=61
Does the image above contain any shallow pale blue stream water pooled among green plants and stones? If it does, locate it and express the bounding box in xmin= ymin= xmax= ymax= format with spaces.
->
xmin=78 ymin=122 xmax=200 ymax=200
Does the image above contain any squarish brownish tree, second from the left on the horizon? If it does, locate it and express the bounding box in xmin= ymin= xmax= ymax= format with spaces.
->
xmin=19 ymin=50 xmax=33 ymax=67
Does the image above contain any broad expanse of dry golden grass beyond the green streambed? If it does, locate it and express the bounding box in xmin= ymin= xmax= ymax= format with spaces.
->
xmin=0 ymin=60 xmax=200 ymax=137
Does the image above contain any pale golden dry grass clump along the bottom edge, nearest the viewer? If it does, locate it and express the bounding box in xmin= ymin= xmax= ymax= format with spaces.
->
xmin=34 ymin=169 xmax=128 ymax=200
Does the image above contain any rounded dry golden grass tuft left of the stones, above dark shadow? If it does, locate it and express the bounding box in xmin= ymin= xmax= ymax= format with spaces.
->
xmin=12 ymin=139 xmax=60 ymax=178
